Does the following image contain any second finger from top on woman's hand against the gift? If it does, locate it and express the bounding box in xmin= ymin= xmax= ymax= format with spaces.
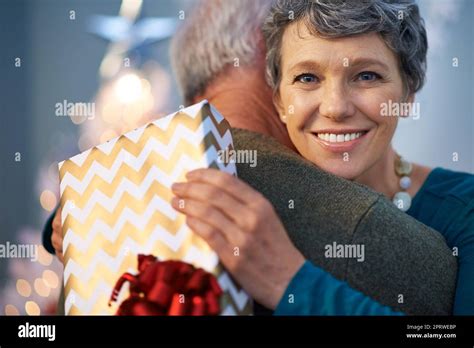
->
xmin=171 ymin=182 xmax=249 ymax=225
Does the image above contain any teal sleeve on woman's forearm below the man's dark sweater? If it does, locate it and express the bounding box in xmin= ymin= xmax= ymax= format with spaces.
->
xmin=274 ymin=261 xmax=404 ymax=315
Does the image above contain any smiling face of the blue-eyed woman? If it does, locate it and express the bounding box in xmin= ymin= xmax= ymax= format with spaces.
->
xmin=275 ymin=22 xmax=411 ymax=180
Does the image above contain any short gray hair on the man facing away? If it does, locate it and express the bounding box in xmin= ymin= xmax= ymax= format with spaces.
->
xmin=170 ymin=0 xmax=273 ymax=104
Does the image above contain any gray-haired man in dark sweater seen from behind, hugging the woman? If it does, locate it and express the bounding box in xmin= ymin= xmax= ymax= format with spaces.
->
xmin=171 ymin=0 xmax=457 ymax=314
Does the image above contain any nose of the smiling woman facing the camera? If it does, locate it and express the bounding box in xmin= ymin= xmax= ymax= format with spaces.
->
xmin=319 ymin=83 xmax=355 ymax=121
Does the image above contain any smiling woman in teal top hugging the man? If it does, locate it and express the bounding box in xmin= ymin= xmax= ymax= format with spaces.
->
xmin=173 ymin=0 xmax=474 ymax=315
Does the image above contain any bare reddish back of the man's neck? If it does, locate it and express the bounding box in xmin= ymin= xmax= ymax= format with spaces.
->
xmin=195 ymin=67 xmax=295 ymax=150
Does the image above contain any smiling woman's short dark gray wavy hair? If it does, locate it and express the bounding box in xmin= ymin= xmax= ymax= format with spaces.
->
xmin=262 ymin=0 xmax=428 ymax=94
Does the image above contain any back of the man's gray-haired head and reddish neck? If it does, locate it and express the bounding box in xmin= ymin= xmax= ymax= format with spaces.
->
xmin=171 ymin=0 xmax=294 ymax=149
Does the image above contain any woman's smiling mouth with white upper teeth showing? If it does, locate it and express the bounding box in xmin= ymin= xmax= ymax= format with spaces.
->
xmin=312 ymin=130 xmax=370 ymax=153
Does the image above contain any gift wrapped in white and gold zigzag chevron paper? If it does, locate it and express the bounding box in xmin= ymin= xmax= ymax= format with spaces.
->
xmin=59 ymin=100 xmax=252 ymax=315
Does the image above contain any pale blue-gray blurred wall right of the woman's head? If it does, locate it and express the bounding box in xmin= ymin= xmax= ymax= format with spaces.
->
xmin=394 ymin=0 xmax=474 ymax=173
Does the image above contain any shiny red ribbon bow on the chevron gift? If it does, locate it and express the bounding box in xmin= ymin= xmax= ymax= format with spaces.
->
xmin=109 ymin=255 xmax=222 ymax=315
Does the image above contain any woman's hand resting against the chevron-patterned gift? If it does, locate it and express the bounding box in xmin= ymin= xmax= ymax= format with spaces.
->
xmin=172 ymin=169 xmax=304 ymax=309
